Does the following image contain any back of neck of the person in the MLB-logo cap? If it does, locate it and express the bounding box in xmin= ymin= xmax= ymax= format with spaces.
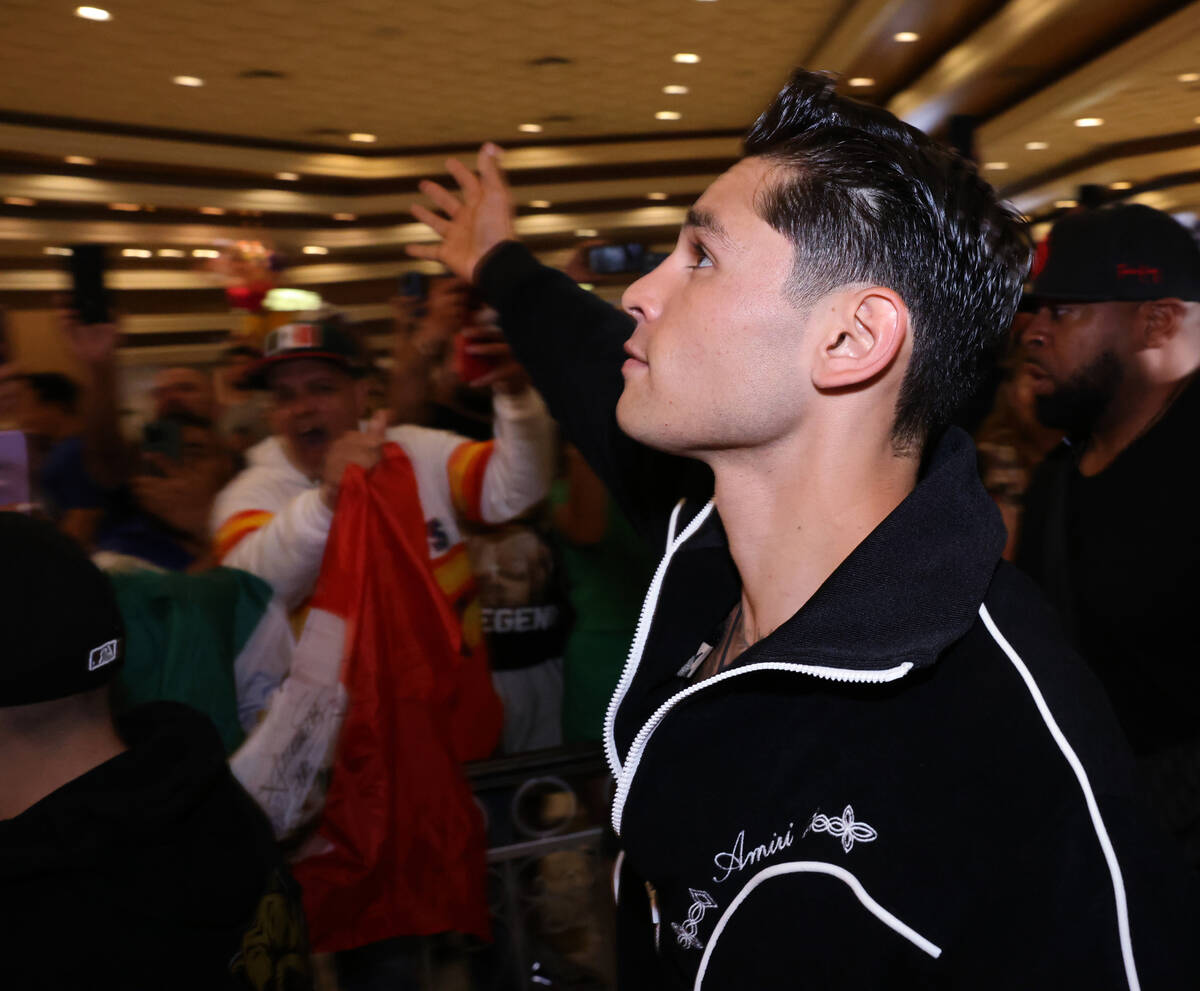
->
xmin=0 ymin=725 xmax=127 ymax=819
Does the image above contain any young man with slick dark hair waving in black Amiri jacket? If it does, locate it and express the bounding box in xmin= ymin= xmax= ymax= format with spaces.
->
xmin=410 ymin=72 xmax=1196 ymax=989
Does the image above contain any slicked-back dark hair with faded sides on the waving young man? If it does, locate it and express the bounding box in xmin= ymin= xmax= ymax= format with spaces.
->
xmin=744 ymin=70 xmax=1033 ymax=451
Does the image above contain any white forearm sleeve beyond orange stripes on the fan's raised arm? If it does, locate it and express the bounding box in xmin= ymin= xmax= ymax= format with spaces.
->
xmin=479 ymin=389 xmax=554 ymax=523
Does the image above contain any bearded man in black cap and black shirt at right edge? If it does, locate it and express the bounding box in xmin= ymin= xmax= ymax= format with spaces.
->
xmin=1016 ymin=204 xmax=1200 ymax=866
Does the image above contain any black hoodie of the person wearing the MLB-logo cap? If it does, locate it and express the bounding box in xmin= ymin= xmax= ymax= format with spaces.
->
xmin=0 ymin=702 xmax=312 ymax=989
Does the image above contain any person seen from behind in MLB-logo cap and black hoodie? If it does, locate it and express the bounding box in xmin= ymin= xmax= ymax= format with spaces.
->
xmin=0 ymin=512 xmax=312 ymax=989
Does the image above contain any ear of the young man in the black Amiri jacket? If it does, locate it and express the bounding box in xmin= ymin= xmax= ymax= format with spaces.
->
xmin=812 ymin=286 xmax=908 ymax=389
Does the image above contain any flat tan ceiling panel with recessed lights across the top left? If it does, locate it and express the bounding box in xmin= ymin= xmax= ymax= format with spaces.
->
xmin=0 ymin=0 xmax=835 ymax=146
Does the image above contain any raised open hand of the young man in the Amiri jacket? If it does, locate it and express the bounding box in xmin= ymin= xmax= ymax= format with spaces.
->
xmin=404 ymin=142 xmax=514 ymax=282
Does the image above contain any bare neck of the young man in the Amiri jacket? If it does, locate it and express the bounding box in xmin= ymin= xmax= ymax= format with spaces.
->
xmin=712 ymin=434 xmax=918 ymax=644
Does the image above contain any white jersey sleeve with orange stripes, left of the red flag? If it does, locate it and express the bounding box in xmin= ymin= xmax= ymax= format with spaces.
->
xmin=214 ymin=469 xmax=334 ymax=609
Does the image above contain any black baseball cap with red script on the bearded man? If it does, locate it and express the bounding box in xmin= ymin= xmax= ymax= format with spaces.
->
xmin=1030 ymin=203 xmax=1200 ymax=302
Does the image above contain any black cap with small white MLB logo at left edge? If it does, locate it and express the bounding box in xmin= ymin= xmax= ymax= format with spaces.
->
xmin=0 ymin=512 xmax=125 ymax=708
